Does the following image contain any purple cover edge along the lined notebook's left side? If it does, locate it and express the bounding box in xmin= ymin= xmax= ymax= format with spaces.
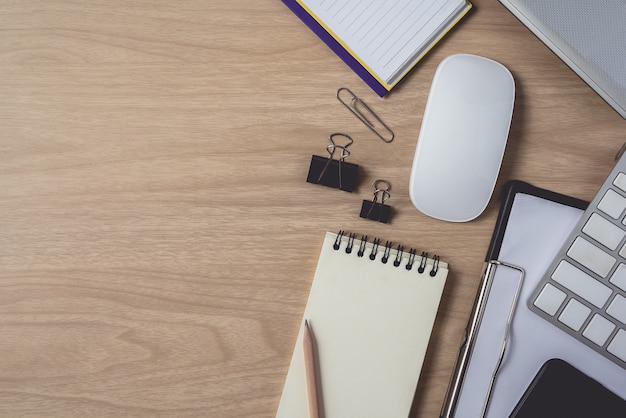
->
xmin=282 ymin=0 xmax=389 ymax=97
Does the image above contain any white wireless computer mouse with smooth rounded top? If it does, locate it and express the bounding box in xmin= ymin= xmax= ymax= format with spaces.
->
xmin=409 ymin=54 xmax=515 ymax=222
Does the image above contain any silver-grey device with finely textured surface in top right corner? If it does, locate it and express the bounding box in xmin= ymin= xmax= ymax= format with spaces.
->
xmin=500 ymin=0 xmax=626 ymax=118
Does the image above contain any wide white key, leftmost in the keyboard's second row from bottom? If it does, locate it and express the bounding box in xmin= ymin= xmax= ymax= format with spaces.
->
xmin=552 ymin=261 xmax=612 ymax=308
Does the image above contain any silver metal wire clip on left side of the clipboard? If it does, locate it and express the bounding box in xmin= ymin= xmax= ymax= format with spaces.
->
xmin=440 ymin=260 xmax=524 ymax=418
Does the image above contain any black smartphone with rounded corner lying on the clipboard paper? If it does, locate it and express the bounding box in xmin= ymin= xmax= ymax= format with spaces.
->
xmin=509 ymin=359 xmax=626 ymax=418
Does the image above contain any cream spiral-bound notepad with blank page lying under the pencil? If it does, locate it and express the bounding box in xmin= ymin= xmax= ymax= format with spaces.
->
xmin=276 ymin=232 xmax=448 ymax=418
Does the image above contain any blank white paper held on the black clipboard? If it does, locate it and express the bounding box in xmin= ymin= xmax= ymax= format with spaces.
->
xmin=454 ymin=193 xmax=626 ymax=418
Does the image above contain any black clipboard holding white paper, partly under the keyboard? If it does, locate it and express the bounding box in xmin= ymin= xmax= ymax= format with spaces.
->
xmin=440 ymin=181 xmax=626 ymax=418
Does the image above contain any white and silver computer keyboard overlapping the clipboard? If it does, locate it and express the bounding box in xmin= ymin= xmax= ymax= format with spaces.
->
xmin=528 ymin=154 xmax=626 ymax=369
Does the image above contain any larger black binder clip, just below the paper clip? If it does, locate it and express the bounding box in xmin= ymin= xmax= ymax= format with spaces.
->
xmin=306 ymin=132 xmax=359 ymax=192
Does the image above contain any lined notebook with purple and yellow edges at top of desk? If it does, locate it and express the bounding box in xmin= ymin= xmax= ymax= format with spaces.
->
xmin=283 ymin=0 xmax=472 ymax=96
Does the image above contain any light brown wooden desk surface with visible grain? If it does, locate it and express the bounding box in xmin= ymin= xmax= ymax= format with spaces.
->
xmin=0 ymin=0 xmax=626 ymax=417
